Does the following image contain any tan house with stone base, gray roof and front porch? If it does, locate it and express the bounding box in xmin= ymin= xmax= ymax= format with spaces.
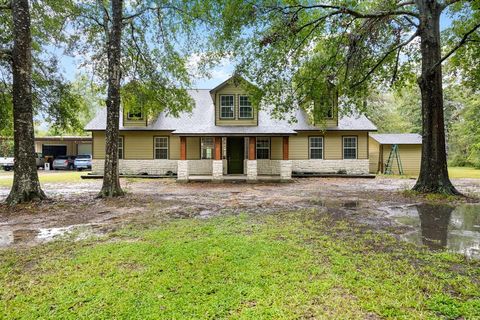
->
xmin=85 ymin=78 xmax=376 ymax=181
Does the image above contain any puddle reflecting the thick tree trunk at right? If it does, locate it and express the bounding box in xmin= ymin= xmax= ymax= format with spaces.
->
xmin=386 ymin=204 xmax=480 ymax=259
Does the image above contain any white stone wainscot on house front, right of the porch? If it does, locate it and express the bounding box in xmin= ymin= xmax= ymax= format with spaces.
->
xmin=292 ymin=159 xmax=369 ymax=174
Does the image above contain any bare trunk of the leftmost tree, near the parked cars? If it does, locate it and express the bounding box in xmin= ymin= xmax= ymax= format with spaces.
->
xmin=6 ymin=0 xmax=46 ymax=205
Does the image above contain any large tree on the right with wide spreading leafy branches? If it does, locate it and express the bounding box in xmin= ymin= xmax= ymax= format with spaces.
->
xmin=216 ymin=0 xmax=480 ymax=194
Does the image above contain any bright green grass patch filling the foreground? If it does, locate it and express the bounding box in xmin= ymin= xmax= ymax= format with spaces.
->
xmin=0 ymin=211 xmax=480 ymax=319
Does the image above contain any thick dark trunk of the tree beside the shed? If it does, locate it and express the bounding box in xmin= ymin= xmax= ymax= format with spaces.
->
xmin=413 ymin=0 xmax=459 ymax=194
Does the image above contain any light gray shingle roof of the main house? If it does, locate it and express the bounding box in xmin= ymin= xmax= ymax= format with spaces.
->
xmin=85 ymin=90 xmax=377 ymax=135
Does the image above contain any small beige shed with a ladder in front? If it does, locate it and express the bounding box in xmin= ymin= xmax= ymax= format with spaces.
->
xmin=369 ymin=133 xmax=422 ymax=175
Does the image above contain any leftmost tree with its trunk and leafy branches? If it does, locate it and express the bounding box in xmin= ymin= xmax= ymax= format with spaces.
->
xmin=0 ymin=0 xmax=91 ymax=204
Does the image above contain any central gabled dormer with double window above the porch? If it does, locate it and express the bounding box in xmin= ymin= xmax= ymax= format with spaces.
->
xmin=210 ymin=76 xmax=258 ymax=126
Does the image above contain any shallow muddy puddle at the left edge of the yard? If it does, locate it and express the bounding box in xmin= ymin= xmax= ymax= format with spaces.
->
xmin=0 ymin=224 xmax=102 ymax=248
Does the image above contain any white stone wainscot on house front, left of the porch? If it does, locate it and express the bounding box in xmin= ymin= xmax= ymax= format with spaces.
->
xmin=92 ymin=159 xmax=177 ymax=175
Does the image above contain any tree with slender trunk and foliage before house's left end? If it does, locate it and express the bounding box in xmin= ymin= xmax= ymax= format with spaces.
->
xmin=70 ymin=0 xmax=218 ymax=197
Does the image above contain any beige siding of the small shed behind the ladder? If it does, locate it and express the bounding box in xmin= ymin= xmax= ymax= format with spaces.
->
xmin=383 ymin=144 xmax=422 ymax=175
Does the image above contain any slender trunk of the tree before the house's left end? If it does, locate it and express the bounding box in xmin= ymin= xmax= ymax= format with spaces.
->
xmin=99 ymin=0 xmax=124 ymax=197
